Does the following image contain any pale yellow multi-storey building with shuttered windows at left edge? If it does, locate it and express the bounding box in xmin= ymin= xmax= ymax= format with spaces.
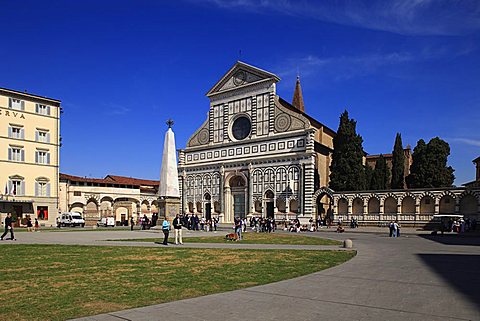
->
xmin=0 ymin=88 xmax=61 ymax=226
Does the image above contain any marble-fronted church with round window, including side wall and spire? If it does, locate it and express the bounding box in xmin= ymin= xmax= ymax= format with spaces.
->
xmin=178 ymin=62 xmax=335 ymax=222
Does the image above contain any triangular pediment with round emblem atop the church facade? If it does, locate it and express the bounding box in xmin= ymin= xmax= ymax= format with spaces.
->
xmin=207 ymin=61 xmax=280 ymax=97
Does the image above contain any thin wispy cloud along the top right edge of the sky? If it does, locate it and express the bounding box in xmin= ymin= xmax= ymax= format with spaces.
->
xmin=193 ymin=0 xmax=480 ymax=35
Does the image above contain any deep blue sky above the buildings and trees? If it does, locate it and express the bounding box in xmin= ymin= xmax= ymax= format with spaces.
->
xmin=0 ymin=0 xmax=480 ymax=185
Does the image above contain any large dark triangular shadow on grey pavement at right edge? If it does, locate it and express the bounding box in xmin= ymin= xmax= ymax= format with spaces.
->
xmin=418 ymin=254 xmax=480 ymax=311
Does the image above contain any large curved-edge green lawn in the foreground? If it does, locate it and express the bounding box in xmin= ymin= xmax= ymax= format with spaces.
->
xmin=0 ymin=244 xmax=355 ymax=320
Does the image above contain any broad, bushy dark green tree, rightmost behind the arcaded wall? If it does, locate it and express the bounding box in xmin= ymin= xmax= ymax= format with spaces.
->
xmin=407 ymin=137 xmax=455 ymax=188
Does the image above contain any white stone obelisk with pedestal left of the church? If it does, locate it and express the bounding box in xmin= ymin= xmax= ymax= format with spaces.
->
xmin=158 ymin=119 xmax=180 ymax=219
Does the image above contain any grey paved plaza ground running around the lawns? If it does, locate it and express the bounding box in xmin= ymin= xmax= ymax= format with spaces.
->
xmin=0 ymin=230 xmax=480 ymax=321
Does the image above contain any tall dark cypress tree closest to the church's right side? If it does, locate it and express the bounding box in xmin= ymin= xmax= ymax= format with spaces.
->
xmin=329 ymin=110 xmax=366 ymax=191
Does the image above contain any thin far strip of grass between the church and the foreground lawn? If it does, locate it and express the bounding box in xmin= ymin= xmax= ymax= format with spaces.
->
xmin=110 ymin=232 xmax=342 ymax=245
